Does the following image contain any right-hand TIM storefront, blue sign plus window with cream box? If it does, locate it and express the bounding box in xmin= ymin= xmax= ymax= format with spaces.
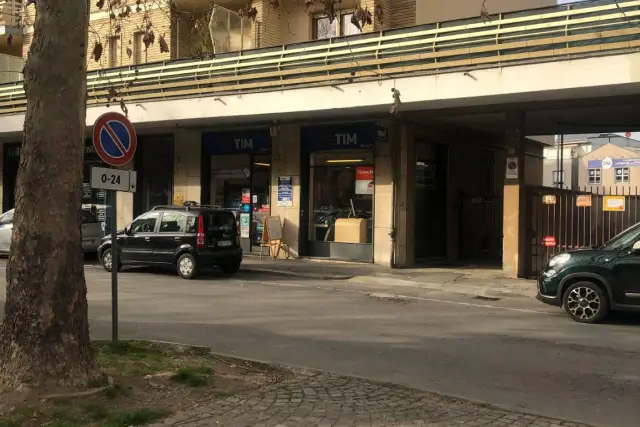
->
xmin=300 ymin=123 xmax=377 ymax=262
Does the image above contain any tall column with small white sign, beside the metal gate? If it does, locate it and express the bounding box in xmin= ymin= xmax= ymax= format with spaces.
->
xmin=502 ymin=111 xmax=527 ymax=277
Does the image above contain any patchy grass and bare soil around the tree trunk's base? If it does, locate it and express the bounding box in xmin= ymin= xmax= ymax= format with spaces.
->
xmin=0 ymin=341 xmax=282 ymax=427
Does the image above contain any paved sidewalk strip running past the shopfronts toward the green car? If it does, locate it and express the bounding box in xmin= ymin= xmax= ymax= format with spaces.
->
xmin=241 ymin=256 xmax=536 ymax=298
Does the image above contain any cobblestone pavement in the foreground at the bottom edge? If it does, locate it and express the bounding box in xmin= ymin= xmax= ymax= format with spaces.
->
xmin=152 ymin=373 xmax=588 ymax=427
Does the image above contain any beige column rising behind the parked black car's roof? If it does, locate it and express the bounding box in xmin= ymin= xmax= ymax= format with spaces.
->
xmin=173 ymin=131 xmax=200 ymax=205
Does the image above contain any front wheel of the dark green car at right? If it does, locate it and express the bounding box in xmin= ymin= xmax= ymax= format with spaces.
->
xmin=562 ymin=281 xmax=610 ymax=323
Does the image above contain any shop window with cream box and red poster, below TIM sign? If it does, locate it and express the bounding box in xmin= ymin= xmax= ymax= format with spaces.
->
xmin=308 ymin=149 xmax=374 ymax=261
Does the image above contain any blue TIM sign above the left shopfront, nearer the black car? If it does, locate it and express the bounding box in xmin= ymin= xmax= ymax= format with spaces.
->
xmin=202 ymin=129 xmax=271 ymax=155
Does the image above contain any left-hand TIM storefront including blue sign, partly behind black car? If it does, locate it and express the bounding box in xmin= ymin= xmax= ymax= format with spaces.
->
xmin=201 ymin=128 xmax=271 ymax=252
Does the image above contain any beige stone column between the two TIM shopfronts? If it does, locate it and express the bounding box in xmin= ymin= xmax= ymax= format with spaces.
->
xmin=271 ymin=125 xmax=306 ymax=258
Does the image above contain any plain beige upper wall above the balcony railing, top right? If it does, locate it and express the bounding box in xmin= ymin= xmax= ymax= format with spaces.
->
xmin=415 ymin=0 xmax=556 ymax=24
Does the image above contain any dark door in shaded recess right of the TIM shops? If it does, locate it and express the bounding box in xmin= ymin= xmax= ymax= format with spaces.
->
xmin=414 ymin=142 xmax=449 ymax=260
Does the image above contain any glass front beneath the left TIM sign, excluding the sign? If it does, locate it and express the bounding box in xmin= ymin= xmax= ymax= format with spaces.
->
xmin=210 ymin=154 xmax=271 ymax=252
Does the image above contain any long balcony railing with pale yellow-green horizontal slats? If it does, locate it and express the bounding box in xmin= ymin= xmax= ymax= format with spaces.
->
xmin=0 ymin=0 xmax=640 ymax=114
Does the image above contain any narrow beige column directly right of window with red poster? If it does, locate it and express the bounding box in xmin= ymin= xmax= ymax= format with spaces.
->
xmin=373 ymin=123 xmax=393 ymax=267
